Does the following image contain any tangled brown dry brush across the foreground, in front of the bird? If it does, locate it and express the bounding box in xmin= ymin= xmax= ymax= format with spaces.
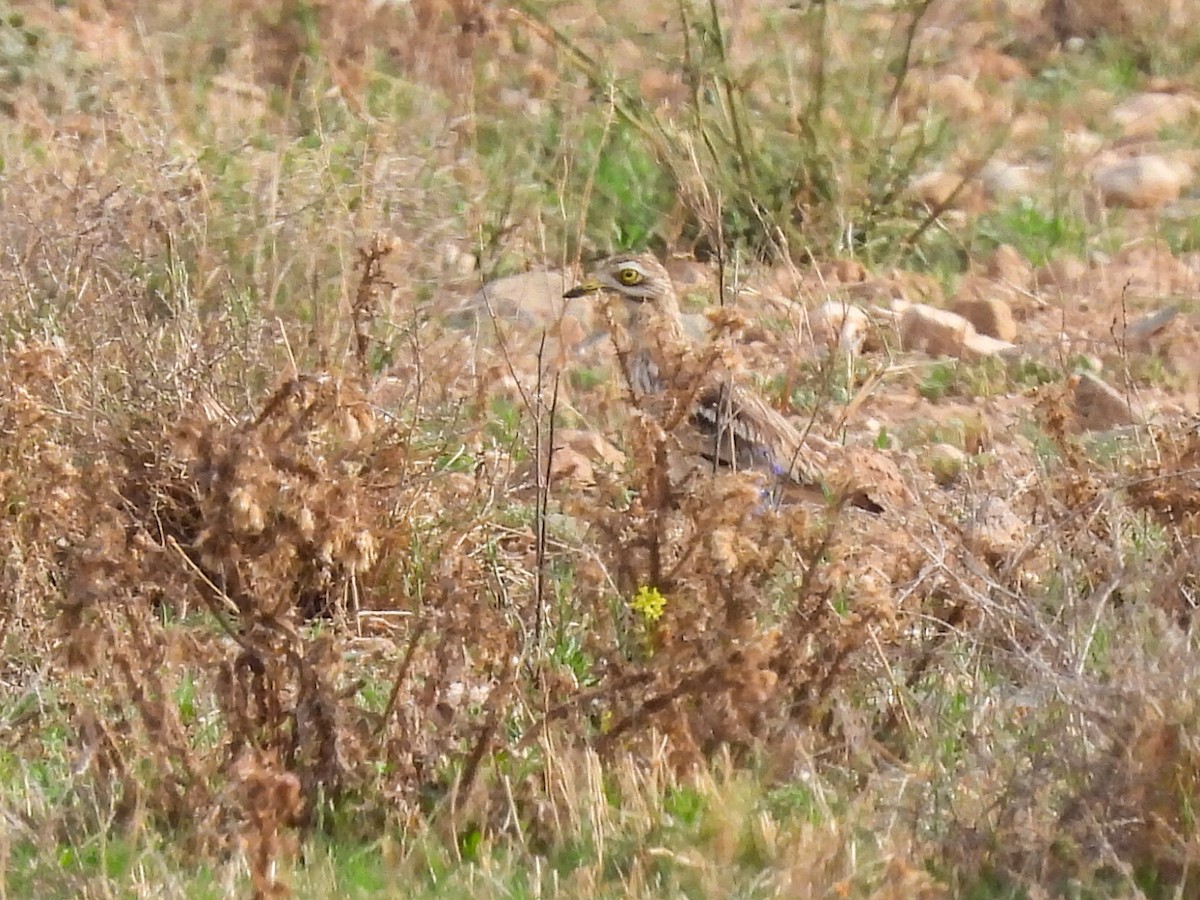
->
xmin=0 ymin=0 xmax=1200 ymax=896
